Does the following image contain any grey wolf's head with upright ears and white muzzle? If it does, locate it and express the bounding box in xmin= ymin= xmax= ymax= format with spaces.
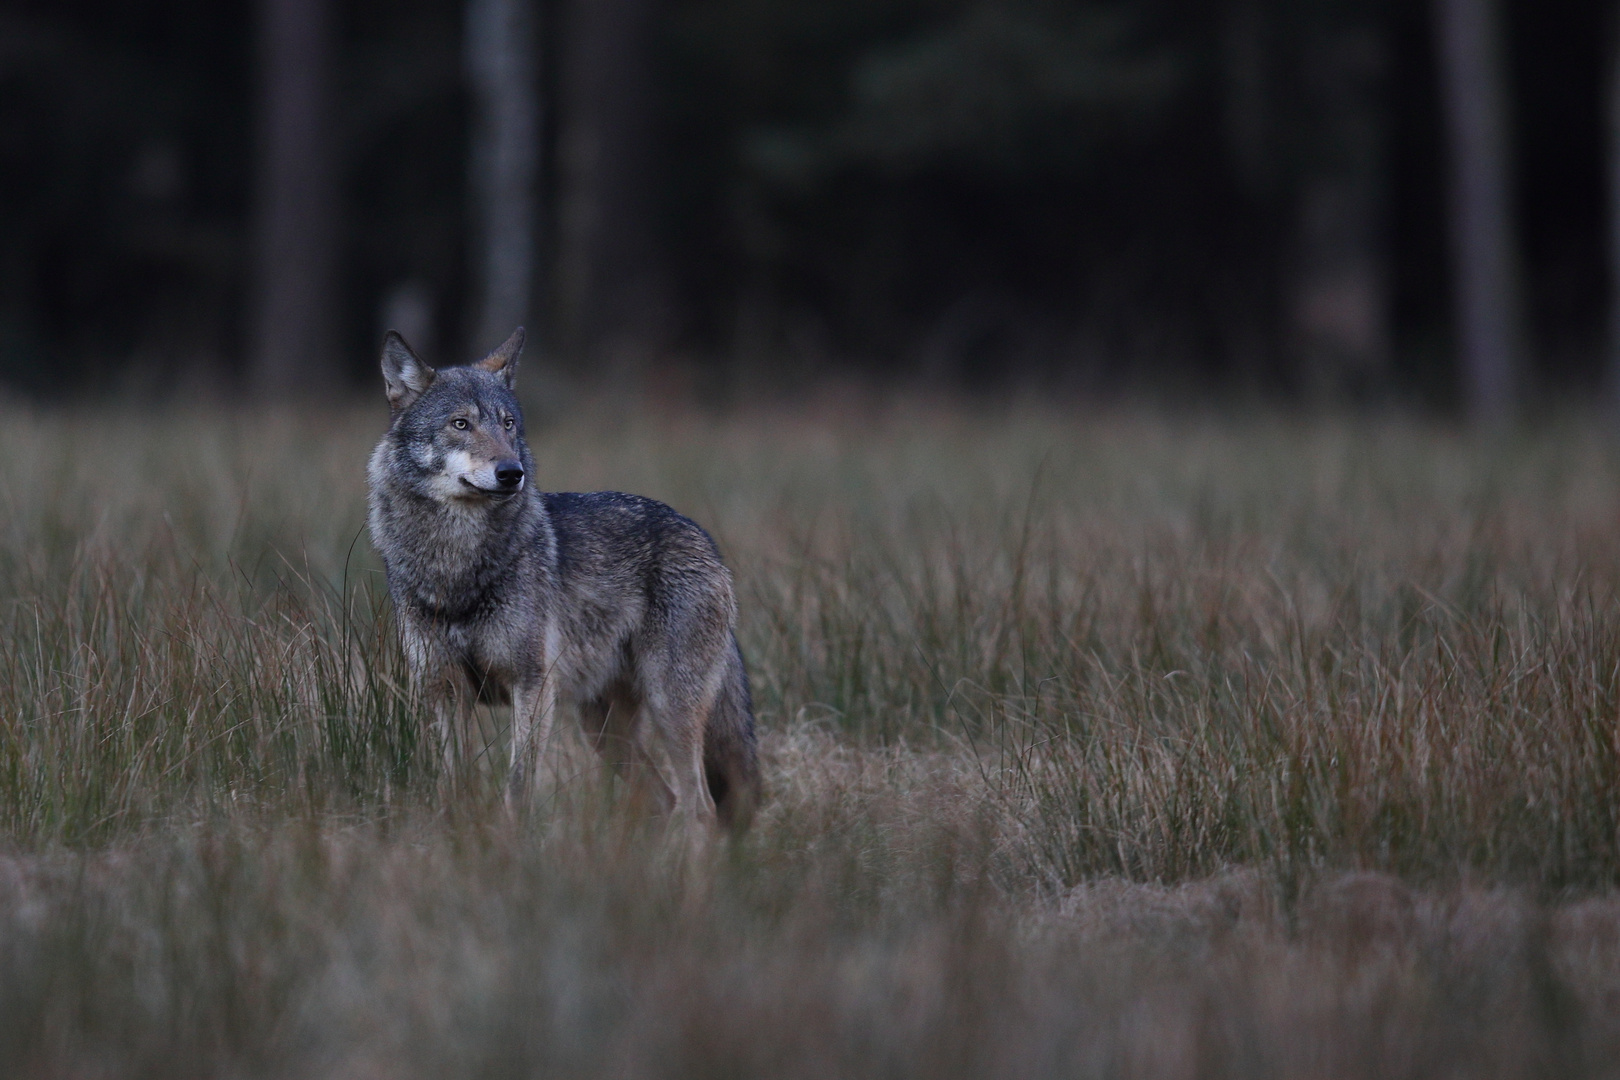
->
xmin=372 ymin=327 xmax=533 ymax=505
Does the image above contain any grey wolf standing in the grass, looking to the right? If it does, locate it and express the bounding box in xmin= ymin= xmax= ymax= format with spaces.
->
xmin=368 ymin=327 xmax=760 ymax=831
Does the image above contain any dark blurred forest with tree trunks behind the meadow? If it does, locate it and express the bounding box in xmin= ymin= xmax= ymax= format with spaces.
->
xmin=0 ymin=0 xmax=1620 ymax=415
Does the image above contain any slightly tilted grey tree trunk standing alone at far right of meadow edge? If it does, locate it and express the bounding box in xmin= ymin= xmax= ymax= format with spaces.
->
xmin=1435 ymin=0 xmax=1524 ymax=424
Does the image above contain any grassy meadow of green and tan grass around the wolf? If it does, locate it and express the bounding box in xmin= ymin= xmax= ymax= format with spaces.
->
xmin=0 ymin=393 xmax=1620 ymax=1080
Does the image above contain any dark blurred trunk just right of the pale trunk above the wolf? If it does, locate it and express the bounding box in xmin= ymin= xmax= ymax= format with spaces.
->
xmin=557 ymin=0 xmax=671 ymax=372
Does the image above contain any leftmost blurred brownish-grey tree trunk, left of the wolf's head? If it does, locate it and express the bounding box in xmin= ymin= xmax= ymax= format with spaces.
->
xmin=248 ymin=0 xmax=337 ymax=397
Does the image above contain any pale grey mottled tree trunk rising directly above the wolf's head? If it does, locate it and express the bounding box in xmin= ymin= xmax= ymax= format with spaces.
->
xmin=463 ymin=0 xmax=539 ymax=351
